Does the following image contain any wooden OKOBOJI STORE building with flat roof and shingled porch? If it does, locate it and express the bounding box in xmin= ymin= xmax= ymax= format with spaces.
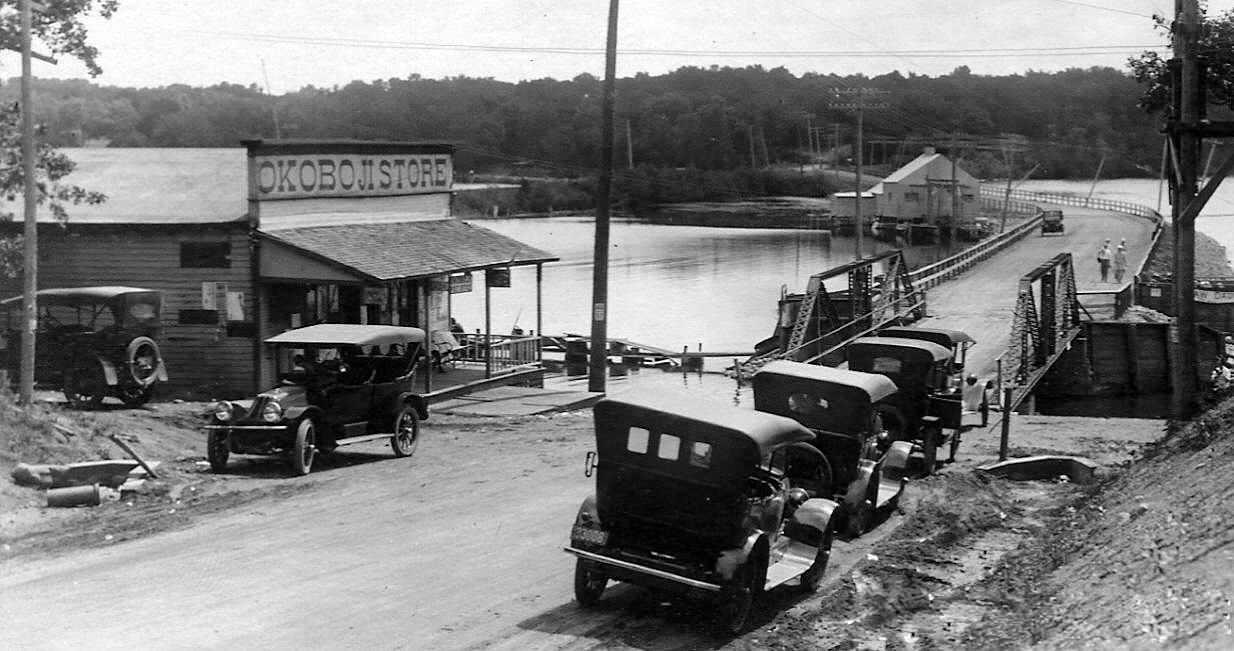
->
xmin=0 ymin=141 xmax=555 ymax=398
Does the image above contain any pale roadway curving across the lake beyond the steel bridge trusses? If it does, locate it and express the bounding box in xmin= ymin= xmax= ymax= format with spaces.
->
xmin=921 ymin=205 xmax=1154 ymax=377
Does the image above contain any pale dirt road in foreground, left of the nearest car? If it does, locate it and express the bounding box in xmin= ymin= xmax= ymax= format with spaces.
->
xmin=0 ymin=414 xmax=895 ymax=649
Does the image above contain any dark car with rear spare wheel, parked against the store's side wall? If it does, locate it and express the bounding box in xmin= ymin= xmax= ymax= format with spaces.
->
xmin=0 ymin=286 xmax=167 ymax=407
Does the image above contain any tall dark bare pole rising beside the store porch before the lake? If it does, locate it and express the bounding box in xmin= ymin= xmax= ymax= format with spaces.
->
xmin=587 ymin=0 xmax=617 ymax=393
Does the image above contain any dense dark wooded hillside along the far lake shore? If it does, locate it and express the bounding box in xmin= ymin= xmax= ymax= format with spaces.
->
xmin=0 ymin=67 xmax=1160 ymax=178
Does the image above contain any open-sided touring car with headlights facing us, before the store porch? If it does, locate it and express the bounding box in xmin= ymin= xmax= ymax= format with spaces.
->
xmin=206 ymin=323 xmax=428 ymax=475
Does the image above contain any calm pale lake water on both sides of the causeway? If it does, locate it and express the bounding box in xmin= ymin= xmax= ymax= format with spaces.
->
xmin=452 ymin=179 xmax=1234 ymax=401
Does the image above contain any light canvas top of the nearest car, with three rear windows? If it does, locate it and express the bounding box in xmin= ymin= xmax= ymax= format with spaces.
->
xmin=594 ymin=395 xmax=814 ymax=464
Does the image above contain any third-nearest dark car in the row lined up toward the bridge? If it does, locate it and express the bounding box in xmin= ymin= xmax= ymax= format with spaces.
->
xmin=847 ymin=337 xmax=964 ymax=473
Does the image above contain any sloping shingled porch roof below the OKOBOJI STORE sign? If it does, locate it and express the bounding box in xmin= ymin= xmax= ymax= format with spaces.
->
xmin=262 ymin=219 xmax=558 ymax=280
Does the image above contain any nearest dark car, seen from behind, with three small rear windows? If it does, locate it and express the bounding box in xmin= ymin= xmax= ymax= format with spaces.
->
xmin=565 ymin=396 xmax=839 ymax=633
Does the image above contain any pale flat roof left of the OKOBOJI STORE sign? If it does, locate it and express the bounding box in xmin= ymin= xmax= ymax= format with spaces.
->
xmin=38 ymin=147 xmax=248 ymax=224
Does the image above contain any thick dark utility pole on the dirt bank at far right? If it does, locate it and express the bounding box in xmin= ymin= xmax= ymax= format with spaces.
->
xmin=1169 ymin=0 xmax=1204 ymax=420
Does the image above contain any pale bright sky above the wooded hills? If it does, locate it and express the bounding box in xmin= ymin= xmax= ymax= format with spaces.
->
xmin=0 ymin=0 xmax=1179 ymax=95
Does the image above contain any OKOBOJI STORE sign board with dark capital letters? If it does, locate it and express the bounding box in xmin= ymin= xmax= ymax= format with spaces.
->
xmin=244 ymin=141 xmax=454 ymax=201
